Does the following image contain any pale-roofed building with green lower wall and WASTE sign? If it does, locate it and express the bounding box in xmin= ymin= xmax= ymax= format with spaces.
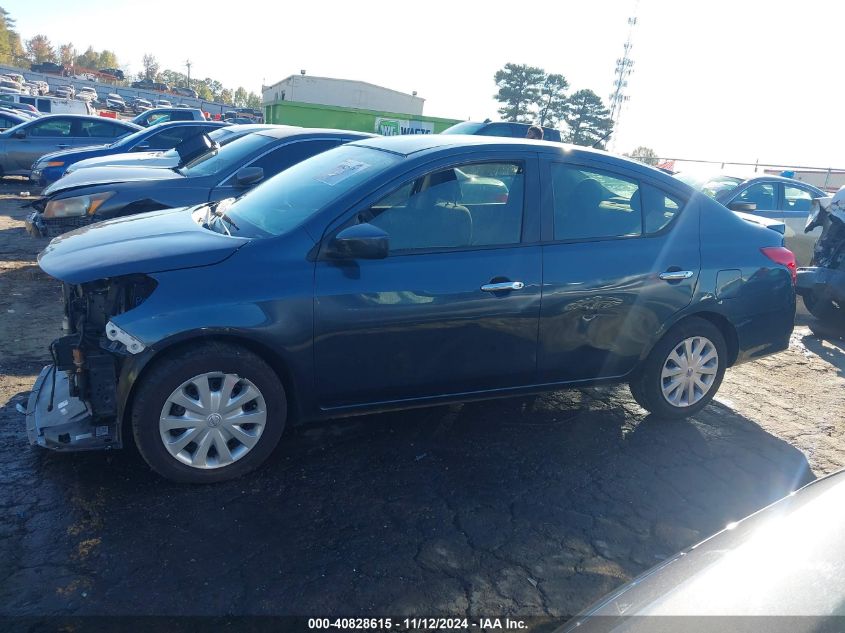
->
xmin=262 ymin=74 xmax=459 ymax=136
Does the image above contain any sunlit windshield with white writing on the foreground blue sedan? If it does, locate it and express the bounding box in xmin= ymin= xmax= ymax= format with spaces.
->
xmin=221 ymin=145 xmax=402 ymax=235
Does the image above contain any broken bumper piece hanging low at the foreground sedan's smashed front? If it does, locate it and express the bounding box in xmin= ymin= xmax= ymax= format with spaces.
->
xmin=26 ymin=365 xmax=119 ymax=451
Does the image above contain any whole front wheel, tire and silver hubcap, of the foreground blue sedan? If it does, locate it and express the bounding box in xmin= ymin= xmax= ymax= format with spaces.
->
xmin=132 ymin=343 xmax=287 ymax=483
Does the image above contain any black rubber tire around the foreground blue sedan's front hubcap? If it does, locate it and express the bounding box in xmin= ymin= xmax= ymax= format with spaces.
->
xmin=131 ymin=342 xmax=287 ymax=483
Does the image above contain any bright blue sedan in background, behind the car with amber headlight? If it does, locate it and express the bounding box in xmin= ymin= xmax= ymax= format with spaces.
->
xmin=30 ymin=121 xmax=228 ymax=186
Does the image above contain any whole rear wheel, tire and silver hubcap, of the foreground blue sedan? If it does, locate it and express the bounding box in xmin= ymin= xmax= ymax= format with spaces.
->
xmin=630 ymin=317 xmax=728 ymax=419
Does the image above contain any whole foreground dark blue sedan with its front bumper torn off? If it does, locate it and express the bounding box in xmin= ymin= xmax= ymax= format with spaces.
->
xmin=27 ymin=135 xmax=795 ymax=482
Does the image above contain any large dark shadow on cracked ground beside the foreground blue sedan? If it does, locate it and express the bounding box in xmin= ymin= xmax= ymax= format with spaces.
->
xmin=0 ymin=387 xmax=813 ymax=616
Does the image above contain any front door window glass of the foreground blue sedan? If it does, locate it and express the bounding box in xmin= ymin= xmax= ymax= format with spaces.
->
xmin=359 ymin=162 xmax=525 ymax=252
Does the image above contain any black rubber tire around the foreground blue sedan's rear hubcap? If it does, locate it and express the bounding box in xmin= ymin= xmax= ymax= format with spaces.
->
xmin=629 ymin=317 xmax=728 ymax=420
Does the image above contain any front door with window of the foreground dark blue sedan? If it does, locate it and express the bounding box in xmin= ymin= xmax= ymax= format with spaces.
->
xmin=314 ymin=152 xmax=542 ymax=410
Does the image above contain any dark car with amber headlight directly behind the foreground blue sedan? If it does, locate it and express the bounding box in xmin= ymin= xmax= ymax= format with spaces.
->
xmin=26 ymin=128 xmax=373 ymax=237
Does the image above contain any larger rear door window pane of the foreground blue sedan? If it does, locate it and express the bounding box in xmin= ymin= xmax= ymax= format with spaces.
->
xmin=551 ymin=163 xmax=643 ymax=240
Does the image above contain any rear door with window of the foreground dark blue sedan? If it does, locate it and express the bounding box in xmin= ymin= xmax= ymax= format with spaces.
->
xmin=538 ymin=160 xmax=700 ymax=383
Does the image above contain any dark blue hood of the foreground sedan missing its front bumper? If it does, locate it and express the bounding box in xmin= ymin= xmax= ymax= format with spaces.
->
xmin=38 ymin=207 xmax=249 ymax=284
